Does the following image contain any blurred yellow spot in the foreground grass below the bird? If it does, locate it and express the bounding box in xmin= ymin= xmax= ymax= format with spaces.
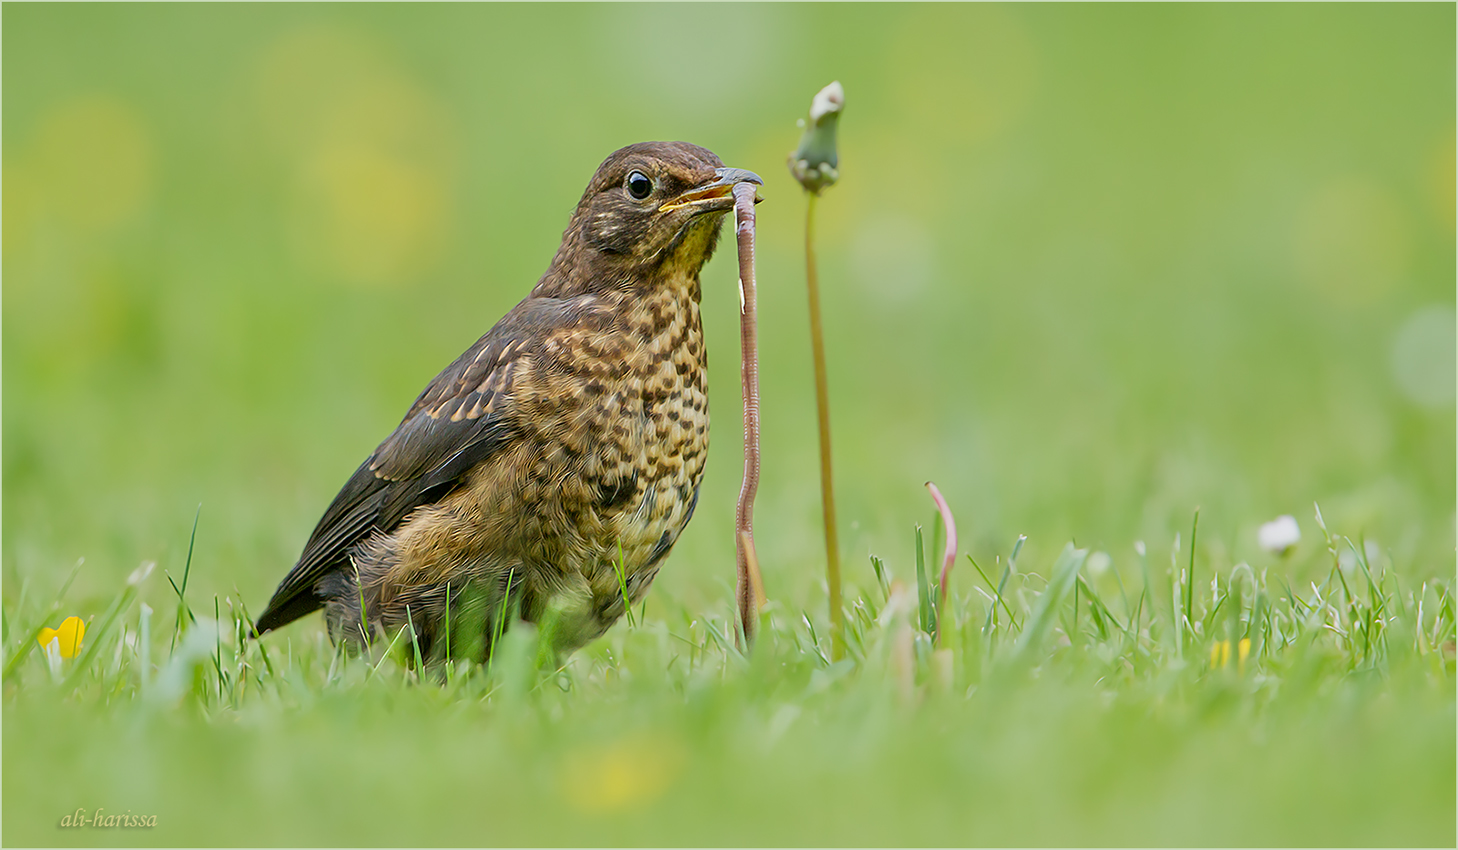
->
xmin=561 ymin=738 xmax=684 ymax=814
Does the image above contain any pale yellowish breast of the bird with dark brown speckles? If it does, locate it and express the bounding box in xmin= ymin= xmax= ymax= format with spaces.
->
xmin=522 ymin=278 xmax=709 ymax=597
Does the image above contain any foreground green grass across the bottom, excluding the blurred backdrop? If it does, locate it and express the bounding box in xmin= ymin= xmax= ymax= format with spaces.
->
xmin=3 ymin=504 xmax=1455 ymax=846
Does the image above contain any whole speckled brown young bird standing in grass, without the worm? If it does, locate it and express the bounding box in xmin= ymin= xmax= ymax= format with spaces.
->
xmin=257 ymin=141 xmax=763 ymax=660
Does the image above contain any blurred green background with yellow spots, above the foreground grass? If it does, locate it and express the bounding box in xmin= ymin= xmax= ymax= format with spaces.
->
xmin=0 ymin=4 xmax=1455 ymax=845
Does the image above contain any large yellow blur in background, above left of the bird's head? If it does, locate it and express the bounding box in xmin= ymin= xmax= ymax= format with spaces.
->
xmin=254 ymin=26 xmax=459 ymax=286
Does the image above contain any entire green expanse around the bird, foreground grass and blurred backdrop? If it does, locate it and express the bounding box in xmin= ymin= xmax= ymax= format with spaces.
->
xmin=0 ymin=4 xmax=1458 ymax=846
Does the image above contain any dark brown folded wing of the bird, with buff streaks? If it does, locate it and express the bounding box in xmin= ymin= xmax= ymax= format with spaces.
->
xmin=257 ymin=297 xmax=603 ymax=633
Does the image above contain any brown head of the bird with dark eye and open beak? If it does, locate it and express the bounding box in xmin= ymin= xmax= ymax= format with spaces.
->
xmin=542 ymin=141 xmax=764 ymax=297
